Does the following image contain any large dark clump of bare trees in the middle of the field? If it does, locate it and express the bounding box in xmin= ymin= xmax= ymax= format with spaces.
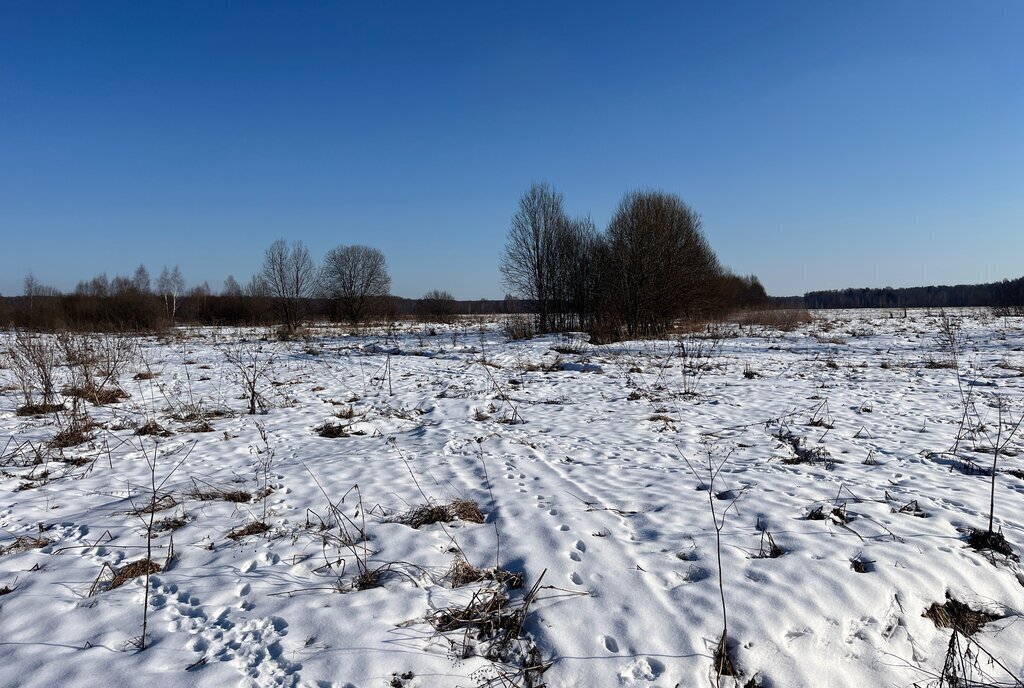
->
xmin=501 ymin=183 xmax=767 ymax=337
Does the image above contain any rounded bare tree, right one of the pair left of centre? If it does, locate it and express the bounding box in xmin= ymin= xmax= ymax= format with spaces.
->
xmin=321 ymin=246 xmax=391 ymax=325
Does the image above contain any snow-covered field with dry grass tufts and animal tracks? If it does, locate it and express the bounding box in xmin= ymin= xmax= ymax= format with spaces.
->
xmin=0 ymin=311 xmax=1024 ymax=688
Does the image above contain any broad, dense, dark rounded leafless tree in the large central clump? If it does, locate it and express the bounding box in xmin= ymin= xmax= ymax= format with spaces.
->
xmin=607 ymin=191 xmax=721 ymax=336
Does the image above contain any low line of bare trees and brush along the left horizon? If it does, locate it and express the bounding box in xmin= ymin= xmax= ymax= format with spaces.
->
xmin=0 ymin=240 xmax=481 ymax=334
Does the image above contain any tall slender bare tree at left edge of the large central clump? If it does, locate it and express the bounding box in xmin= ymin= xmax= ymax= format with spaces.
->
xmin=501 ymin=182 xmax=568 ymax=332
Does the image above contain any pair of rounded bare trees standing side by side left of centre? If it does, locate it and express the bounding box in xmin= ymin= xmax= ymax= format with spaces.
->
xmin=258 ymin=239 xmax=391 ymax=331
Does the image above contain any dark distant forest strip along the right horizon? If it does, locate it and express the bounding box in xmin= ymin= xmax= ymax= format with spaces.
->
xmin=804 ymin=277 xmax=1024 ymax=310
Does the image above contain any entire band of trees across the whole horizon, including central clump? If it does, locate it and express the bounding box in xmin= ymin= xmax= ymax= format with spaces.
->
xmin=0 ymin=188 xmax=1024 ymax=333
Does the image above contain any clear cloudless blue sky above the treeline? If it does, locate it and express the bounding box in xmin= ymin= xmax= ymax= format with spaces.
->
xmin=0 ymin=0 xmax=1024 ymax=298
